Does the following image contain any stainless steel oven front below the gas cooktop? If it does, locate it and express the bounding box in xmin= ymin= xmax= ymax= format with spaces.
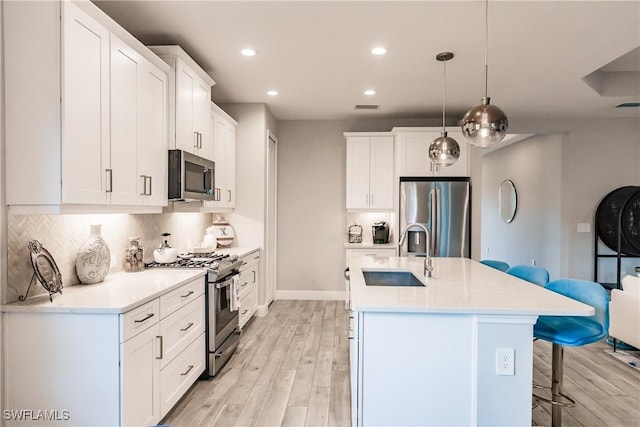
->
xmin=207 ymin=271 xmax=240 ymax=376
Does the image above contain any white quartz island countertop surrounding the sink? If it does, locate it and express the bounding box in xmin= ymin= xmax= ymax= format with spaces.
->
xmin=349 ymin=256 xmax=594 ymax=316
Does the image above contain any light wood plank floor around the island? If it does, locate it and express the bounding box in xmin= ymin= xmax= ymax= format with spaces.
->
xmin=162 ymin=300 xmax=640 ymax=427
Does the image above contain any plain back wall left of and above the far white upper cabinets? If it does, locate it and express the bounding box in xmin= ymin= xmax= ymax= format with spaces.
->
xmin=277 ymin=119 xmax=437 ymax=298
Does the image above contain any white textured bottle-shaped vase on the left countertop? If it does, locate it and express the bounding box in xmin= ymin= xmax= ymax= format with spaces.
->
xmin=76 ymin=224 xmax=111 ymax=285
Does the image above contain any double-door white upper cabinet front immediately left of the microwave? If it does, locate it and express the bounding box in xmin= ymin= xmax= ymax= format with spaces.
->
xmin=110 ymin=34 xmax=167 ymax=206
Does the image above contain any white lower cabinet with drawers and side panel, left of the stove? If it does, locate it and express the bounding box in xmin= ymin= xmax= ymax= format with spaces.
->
xmin=3 ymin=277 xmax=205 ymax=426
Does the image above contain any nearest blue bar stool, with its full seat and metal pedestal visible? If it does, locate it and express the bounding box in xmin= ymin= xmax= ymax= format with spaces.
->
xmin=533 ymin=279 xmax=609 ymax=427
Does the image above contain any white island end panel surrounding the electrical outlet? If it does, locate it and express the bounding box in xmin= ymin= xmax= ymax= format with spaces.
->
xmin=475 ymin=316 xmax=537 ymax=426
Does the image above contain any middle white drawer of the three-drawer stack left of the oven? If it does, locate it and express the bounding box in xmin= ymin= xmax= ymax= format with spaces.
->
xmin=160 ymin=295 xmax=204 ymax=369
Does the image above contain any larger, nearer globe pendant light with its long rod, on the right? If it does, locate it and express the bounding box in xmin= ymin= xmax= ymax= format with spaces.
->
xmin=461 ymin=0 xmax=509 ymax=148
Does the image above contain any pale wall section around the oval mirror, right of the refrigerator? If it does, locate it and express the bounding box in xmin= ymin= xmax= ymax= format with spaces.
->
xmin=480 ymin=134 xmax=563 ymax=278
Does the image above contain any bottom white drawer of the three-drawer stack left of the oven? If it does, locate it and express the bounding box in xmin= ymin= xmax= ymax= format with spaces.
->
xmin=160 ymin=333 xmax=205 ymax=416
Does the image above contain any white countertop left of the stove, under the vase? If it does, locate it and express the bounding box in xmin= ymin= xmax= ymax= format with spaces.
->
xmin=2 ymin=269 xmax=205 ymax=314
